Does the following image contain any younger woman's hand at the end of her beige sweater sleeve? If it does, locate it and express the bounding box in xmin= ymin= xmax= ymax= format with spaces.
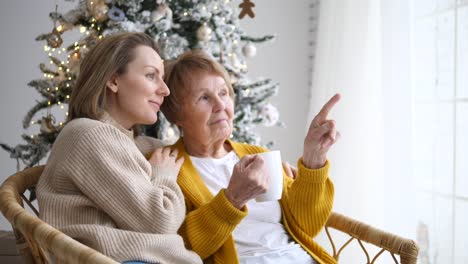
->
xmin=148 ymin=147 xmax=184 ymax=182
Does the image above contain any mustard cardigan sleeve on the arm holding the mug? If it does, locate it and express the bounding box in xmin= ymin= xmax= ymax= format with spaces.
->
xmin=181 ymin=189 xmax=248 ymax=259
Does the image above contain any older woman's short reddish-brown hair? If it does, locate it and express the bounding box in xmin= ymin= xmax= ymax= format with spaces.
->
xmin=161 ymin=49 xmax=234 ymax=124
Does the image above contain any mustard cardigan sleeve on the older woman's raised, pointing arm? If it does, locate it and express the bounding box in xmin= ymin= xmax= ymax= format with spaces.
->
xmin=281 ymin=159 xmax=334 ymax=237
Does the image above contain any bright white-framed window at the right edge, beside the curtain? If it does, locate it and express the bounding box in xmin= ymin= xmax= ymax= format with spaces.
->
xmin=412 ymin=0 xmax=468 ymax=264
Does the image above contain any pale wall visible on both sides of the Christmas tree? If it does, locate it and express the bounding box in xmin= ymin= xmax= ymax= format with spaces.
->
xmin=0 ymin=0 xmax=314 ymax=229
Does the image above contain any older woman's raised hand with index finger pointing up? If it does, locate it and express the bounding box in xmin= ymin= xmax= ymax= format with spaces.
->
xmin=302 ymin=94 xmax=341 ymax=169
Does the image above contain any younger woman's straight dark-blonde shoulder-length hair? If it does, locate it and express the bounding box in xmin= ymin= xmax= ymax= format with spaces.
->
xmin=68 ymin=32 xmax=158 ymax=121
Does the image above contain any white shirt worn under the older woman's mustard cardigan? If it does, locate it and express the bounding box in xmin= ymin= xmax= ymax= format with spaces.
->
xmin=190 ymin=151 xmax=316 ymax=264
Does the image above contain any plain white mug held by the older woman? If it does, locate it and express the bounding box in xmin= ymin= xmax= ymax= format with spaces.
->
xmin=255 ymin=150 xmax=283 ymax=202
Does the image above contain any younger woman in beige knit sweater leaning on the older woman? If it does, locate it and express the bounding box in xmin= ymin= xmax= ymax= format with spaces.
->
xmin=37 ymin=33 xmax=201 ymax=263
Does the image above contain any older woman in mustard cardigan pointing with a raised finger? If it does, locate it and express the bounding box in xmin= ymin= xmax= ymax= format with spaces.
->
xmin=161 ymin=51 xmax=339 ymax=264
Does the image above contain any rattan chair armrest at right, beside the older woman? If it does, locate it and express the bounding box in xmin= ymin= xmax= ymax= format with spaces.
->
xmin=325 ymin=212 xmax=419 ymax=264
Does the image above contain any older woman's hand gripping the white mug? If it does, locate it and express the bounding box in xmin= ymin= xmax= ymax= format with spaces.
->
xmin=225 ymin=155 xmax=270 ymax=209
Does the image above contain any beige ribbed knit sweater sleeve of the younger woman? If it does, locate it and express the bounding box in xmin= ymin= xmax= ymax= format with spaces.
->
xmin=62 ymin=124 xmax=185 ymax=234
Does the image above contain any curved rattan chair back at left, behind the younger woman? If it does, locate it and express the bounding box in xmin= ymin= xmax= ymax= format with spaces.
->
xmin=0 ymin=166 xmax=117 ymax=264
